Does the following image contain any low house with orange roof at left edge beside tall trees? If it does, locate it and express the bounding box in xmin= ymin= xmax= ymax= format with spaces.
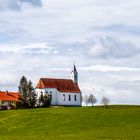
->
xmin=0 ymin=91 xmax=20 ymax=109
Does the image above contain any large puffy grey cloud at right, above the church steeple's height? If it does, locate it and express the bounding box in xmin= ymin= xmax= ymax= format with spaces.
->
xmin=87 ymin=37 xmax=140 ymax=59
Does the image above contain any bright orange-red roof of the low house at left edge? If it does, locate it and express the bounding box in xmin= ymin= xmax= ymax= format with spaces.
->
xmin=0 ymin=91 xmax=20 ymax=102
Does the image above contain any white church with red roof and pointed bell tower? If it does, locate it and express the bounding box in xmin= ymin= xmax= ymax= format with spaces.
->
xmin=35 ymin=65 xmax=82 ymax=106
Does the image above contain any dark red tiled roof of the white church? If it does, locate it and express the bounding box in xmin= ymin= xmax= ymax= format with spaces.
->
xmin=36 ymin=78 xmax=81 ymax=93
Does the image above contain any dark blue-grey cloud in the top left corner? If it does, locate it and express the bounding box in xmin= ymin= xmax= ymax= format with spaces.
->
xmin=0 ymin=0 xmax=42 ymax=10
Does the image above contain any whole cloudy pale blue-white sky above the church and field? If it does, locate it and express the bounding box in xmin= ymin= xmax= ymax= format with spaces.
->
xmin=0 ymin=0 xmax=140 ymax=104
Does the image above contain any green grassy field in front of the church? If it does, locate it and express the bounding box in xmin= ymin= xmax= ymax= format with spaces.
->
xmin=0 ymin=106 xmax=140 ymax=140
